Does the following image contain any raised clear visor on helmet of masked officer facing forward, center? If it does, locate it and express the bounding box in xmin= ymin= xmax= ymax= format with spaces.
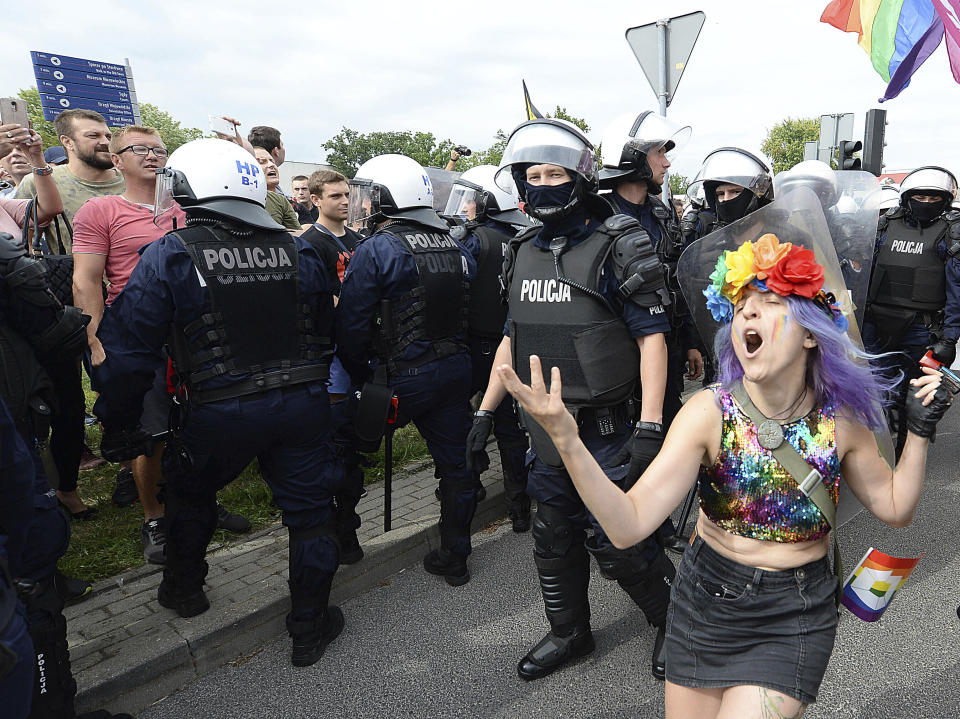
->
xmin=494 ymin=120 xmax=597 ymax=192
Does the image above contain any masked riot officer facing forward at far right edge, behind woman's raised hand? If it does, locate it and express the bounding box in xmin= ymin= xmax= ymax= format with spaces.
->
xmin=863 ymin=166 xmax=960 ymax=456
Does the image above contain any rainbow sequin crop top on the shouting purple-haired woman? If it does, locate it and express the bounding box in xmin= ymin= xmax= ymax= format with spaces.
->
xmin=699 ymin=385 xmax=840 ymax=542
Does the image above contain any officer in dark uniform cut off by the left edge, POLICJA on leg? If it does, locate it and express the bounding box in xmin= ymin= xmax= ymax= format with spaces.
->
xmin=0 ymin=233 xmax=128 ymax=719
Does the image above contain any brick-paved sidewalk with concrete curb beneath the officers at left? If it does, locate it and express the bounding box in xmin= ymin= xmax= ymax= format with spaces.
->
xmin=66 ymin=447 xmax=506 ymax=713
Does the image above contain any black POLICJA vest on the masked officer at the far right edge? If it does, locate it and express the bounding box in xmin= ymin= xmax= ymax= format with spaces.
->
xmin=868 ymin=218 xmax=947 ymax=312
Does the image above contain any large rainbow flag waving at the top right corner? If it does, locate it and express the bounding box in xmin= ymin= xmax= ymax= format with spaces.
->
xmin=820 ymin=0 xmax=960 ymax=102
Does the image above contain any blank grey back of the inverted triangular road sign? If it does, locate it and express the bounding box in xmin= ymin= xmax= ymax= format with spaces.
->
xmin=627 ymin=11 xmax=707 ymax=107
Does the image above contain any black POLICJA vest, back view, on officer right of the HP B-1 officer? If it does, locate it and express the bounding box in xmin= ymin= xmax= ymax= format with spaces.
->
xmin=377 ymin=222 xmax=469 ymax=371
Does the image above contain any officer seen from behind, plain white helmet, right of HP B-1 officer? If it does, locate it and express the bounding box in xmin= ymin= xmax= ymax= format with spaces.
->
xmin=337 ymin=155 xmax=477 ymax=586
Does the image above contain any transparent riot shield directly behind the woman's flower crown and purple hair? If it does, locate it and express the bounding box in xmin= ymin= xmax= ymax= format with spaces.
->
xmin=677 ymin=186 xmax=894 ymax=524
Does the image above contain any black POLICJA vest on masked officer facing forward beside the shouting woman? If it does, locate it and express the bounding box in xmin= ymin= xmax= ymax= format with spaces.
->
xmin=508 ymin=228 xmax=640 ymax=408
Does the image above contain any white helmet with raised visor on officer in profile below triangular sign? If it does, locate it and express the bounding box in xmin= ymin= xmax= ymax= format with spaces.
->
xmin=600 ymin=110 xmax=690 ymax=192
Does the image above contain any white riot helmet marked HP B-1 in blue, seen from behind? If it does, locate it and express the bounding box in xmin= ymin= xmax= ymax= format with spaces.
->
xmin=154 ymin=138 xmax=285 ymax=230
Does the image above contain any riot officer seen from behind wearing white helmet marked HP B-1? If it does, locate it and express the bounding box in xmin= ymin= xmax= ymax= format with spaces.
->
xmin=95 ymin=139 xmax=344 ymax=666
